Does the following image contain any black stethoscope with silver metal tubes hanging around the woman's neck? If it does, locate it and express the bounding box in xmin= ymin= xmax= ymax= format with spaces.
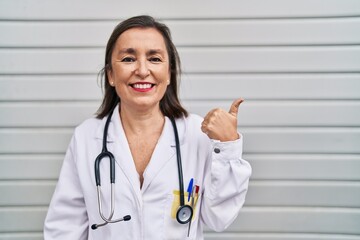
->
xmin=91 ymin=106 xmax=193 ymax=230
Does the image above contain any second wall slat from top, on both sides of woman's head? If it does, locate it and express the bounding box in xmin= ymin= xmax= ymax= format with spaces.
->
xmin=0 ymin=18 xmax=360 ymax=47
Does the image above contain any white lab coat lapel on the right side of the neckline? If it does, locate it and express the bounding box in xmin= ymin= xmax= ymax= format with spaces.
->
xmin=141 ymin=117 xmax=183 ymax=193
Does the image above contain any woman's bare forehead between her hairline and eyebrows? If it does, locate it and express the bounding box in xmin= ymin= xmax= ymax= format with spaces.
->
xmin=116 ymin=28 xmax=166 ymax=51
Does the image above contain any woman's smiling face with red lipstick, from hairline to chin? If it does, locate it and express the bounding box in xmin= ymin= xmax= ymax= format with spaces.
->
xmin=107 ymin=28 xmax=170 ymax=111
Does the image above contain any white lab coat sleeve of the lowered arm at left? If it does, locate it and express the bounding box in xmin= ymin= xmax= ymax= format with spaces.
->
xmin=44 ymin=134 xmax=88 ymax=240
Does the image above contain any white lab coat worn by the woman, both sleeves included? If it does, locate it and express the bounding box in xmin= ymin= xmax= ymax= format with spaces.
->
xmin=44 ymin=105 xmax=251 ymax=240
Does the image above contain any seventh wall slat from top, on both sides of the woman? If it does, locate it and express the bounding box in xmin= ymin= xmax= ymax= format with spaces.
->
xmin=0 ymin=154 xmax=360 ymax=181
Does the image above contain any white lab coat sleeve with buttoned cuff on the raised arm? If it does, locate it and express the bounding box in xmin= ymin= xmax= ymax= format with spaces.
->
xmin=201 ymin=135 xmax=251 ymax=232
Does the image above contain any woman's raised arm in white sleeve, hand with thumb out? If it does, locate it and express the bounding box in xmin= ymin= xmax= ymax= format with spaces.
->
xmin=201 ymin=99 xmax=251 ymax=231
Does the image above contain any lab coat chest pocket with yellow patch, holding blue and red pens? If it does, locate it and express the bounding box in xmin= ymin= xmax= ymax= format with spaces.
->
xmin=164 ymin=190 xmax=197 ymax=240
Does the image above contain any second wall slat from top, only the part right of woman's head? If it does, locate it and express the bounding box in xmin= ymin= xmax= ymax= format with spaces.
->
xmin=171 ymin=18 xmax=360 ymax=46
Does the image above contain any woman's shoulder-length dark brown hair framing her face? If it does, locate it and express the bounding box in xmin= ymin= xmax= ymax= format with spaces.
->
xmin=96 ymin=15 xmax=188 ymax=118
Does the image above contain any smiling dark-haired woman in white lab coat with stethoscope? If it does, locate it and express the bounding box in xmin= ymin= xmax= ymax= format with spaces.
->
xmin=44 ymin=16 xmax=251 ymax=239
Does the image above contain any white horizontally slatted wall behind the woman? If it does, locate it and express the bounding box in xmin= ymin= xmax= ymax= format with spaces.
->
xmin=0 ymin=0 xmax=360 ymax=240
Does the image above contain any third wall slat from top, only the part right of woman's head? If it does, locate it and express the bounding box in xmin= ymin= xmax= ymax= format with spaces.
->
xmin=179 ymin=46 xmax=360 ymax=73
